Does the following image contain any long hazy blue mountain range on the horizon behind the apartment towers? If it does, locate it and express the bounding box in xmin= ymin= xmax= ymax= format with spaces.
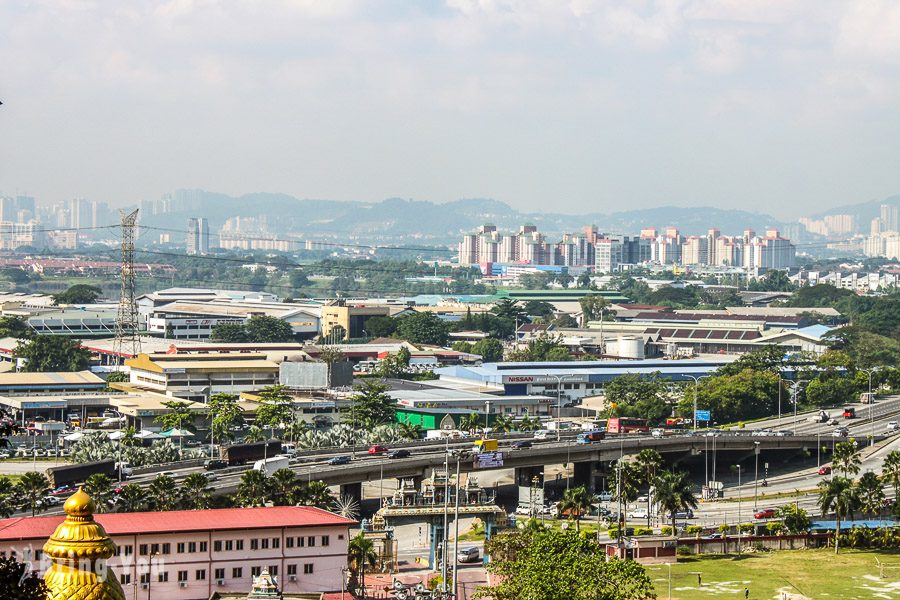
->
xmin=141 ymin=190 xmax=784 ymax=243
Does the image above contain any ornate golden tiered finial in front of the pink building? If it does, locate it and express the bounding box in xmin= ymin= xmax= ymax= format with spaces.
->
xmin=44 ymin=488 xmax=125 ymax=600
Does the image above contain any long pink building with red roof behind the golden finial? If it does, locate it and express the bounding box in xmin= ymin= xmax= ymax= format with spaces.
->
xmin=0 ymin=506 xmax=356 ymax=600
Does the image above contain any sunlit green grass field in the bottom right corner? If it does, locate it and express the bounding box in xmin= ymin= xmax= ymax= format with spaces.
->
xmin=648 ymin=549 xmax=900 ymax=600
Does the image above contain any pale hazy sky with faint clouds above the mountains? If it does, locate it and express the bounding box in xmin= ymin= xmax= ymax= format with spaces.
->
xmin=0 ymin=0 xmax=900 ymax=218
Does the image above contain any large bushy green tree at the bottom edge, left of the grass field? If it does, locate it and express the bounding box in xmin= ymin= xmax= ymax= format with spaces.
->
xmin=478 ymin=528 xmax=655 ymax=600
